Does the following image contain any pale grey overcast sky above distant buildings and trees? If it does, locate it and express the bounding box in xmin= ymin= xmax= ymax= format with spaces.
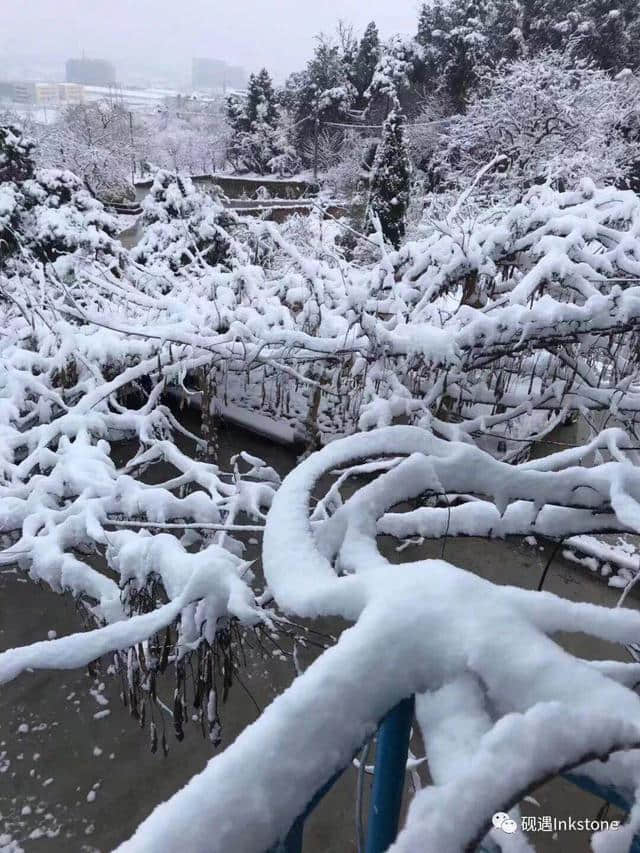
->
xmin=0 ymin=0 xmax=419 ymax=78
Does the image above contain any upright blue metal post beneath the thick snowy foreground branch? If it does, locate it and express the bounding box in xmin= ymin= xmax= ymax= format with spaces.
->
xmin=365 ymin=696 xmax=414 ymax=853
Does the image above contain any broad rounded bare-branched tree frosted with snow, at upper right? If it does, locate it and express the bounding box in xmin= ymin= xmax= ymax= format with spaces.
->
xmin=436 ymin=53 xmax=639 ymax=197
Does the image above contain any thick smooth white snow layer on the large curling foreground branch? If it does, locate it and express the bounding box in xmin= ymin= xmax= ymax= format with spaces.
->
xmin=119 ymin=427 xmax=640 ymax=851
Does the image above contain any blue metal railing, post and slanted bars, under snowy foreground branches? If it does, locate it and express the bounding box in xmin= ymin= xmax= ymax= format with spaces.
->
xmin=267 ymin=696 xmax=640 ymax=853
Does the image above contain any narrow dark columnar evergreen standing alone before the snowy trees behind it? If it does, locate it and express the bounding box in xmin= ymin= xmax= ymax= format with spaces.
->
xmin=369 ymin=104 xmax=411 ymax=248
